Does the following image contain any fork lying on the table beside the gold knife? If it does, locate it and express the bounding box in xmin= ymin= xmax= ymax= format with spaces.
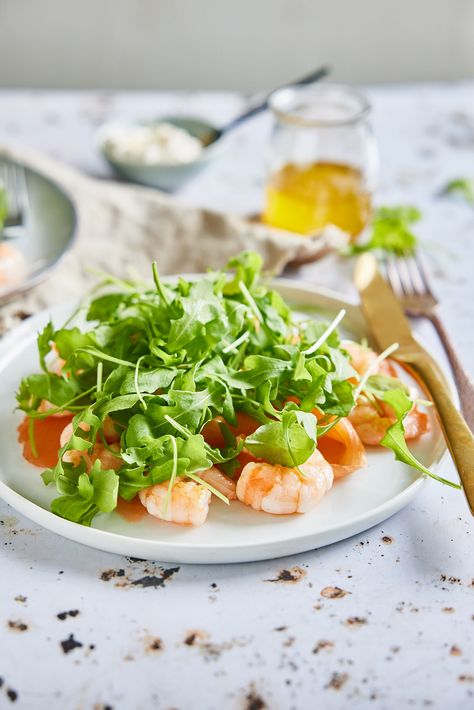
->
xmin=382 ymin=252 xmax=474 ymax=431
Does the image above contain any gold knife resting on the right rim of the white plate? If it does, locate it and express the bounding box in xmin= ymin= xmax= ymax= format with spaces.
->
xmin=354 ymin=254 xmax=474 ymax=515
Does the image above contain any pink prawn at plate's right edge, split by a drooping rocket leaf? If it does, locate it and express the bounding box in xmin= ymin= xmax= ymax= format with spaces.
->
xmin=348 ymin=400 xmax=430 ymax=446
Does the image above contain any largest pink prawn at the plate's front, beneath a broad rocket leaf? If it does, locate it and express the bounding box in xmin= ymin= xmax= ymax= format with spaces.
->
xmin=237 ymin=449 xmax=334 ymax=515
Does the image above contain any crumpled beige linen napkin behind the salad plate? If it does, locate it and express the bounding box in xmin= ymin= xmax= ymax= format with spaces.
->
xmin=0 ymin=146 xmax=337 ymax=335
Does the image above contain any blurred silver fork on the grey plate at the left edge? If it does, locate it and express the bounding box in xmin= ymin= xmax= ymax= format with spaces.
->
xmin=0 ymin=162 xmax=29 ymax=239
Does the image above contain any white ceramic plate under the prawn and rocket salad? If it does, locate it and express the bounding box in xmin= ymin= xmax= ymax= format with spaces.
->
xmin=0 ymin=280 xmax=445 ymax=564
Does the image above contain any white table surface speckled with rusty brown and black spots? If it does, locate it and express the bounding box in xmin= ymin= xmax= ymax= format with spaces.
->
xmin=0 ymin=83 xmax=474 ymax=710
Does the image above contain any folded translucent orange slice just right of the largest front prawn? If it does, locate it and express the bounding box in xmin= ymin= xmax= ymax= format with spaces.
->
xmin=318 ymin=418 xmax=367 ymax=479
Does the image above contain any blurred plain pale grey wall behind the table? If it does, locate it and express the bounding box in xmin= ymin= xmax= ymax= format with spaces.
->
xmin=0 ymin=0 xmax=474 ymax=91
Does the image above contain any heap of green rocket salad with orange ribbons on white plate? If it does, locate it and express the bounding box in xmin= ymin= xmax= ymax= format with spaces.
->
xmin=17 ymin=252 xmax=456 ymax=525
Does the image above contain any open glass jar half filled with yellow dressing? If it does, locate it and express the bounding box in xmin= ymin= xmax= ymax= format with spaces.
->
xmin=263 ymin=84 xmax=378 ymax=238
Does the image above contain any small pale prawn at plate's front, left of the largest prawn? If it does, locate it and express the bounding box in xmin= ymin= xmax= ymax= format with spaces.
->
xmin=138 ymin=479 xmax=211 ymax=526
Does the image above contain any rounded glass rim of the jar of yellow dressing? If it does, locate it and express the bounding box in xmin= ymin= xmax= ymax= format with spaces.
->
xmin=268 ymin=83 xmax=371 ymax=128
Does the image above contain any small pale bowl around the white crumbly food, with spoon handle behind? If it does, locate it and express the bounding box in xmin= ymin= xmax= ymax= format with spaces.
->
xmin=96 ymin=116 xmax=223 ymax=192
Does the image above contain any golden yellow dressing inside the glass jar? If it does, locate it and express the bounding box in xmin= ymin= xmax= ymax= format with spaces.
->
xmin=263 ymin=162 xmax=371 ymax=237
